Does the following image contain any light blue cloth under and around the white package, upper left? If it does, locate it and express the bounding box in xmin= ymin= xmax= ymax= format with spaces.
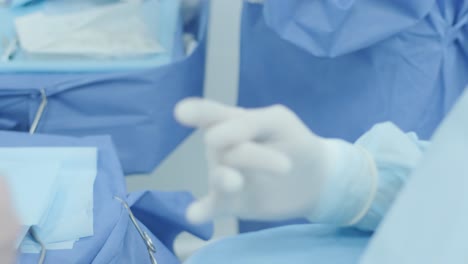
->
xmin=0 ymin=0 xmax=183 ymax=72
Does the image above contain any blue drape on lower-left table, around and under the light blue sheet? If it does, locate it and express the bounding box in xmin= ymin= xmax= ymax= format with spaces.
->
xmin=0 ymin=132 xmax=211 ymax=264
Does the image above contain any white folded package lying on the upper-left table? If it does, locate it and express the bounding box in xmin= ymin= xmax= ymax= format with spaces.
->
xmin=15 ymin=2 xmax=164 ymax=57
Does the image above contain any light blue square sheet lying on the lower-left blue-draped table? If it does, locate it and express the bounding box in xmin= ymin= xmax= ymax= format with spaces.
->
xmin=0 ymin=147 xmax=97 ymax=253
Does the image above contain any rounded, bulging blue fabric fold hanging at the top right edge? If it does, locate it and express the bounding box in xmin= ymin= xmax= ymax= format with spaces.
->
xmin=263 ymin=0 xmax=435 ymax=57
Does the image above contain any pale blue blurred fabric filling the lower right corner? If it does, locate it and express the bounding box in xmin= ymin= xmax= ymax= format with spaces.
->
xmin=361 ymin=90 xmax=468 ymax=264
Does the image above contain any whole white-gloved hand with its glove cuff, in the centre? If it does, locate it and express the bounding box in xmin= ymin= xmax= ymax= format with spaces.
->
xmin=175 ymin=98 xmax=377 ymax=225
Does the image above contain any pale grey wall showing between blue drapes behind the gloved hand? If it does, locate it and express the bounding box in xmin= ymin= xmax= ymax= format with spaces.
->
xmin=127 ymin=0 xmax=242 ymax=239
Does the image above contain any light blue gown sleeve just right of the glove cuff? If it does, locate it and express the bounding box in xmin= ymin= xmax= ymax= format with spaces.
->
xmin=355 ymin=122 xmax=429 ymax=230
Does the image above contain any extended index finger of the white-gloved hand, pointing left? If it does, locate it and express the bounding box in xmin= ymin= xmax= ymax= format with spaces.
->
xmin=174 ymin=97 xmax=243 ymax=128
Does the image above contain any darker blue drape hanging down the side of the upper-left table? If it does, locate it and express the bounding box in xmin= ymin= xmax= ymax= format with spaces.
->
xmin=0 ymin=65 xmax=201 ymax=173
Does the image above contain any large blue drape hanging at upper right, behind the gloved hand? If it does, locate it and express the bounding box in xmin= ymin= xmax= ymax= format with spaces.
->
xmin=239 ymin=0 xmax=468 ymax=230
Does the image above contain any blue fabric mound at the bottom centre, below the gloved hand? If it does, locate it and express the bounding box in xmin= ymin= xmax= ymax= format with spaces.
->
xmin=185 ymin=224 xmax=369 ymax=264
